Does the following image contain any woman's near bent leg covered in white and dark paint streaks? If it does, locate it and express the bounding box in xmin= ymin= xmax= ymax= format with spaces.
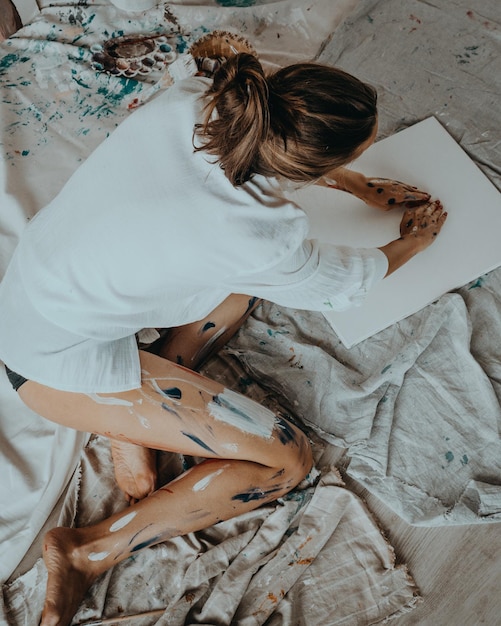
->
xmin=19 ymin=352 xmax=312 ymax=626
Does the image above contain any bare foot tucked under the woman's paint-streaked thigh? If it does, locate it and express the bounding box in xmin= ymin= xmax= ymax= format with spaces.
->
xmin=111 ymin=440 xmax=157 ymax=504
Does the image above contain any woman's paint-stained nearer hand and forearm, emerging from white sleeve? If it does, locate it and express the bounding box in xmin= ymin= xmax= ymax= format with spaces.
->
xmin=379 ymin=200 xmax=447 ymax=276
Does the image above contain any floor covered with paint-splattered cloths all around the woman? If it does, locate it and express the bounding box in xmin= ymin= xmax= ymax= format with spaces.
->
xmin=0 ymin=0 xmax=501 ymax=626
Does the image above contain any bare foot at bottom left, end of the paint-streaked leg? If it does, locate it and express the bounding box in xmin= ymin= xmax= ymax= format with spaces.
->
xmin=40 ymin=528 xmax=99 ymax=626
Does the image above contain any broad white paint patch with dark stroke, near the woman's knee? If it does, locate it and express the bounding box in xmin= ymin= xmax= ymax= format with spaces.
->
xmin=208 ymin=389 xmax=276 ymax=439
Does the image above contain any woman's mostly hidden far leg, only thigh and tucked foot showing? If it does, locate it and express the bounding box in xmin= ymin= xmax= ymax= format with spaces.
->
xmin=111 ymin=294 xmax=261 ymax=502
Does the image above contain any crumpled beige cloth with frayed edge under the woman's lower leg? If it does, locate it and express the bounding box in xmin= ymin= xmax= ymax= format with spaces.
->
xmin=0 ymin=437 xmax=419 ymax=626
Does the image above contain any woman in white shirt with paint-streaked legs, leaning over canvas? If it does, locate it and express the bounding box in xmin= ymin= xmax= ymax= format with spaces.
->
xmin=0 ymin=42 xmax=446 ymax=626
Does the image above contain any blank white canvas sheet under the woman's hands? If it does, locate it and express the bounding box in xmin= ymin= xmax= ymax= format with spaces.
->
xmin=290 ymin=117 xmax=501 ymax=348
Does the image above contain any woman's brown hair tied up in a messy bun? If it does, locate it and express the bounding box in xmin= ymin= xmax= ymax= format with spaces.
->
xmin=196 ymin=53 xmax=377 ymax=185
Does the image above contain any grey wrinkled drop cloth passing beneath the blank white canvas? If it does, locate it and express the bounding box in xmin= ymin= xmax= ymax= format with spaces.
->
xmin=227 ymin=0 xmax=501 ymax=525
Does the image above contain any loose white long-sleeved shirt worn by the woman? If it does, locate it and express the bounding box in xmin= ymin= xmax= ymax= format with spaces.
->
xmin=0 ymin=77 xmax=387 ymax=393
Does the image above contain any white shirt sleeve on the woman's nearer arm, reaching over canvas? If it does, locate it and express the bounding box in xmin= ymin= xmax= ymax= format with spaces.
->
xmin=227 ymin=239 xmax=388 ymax=311
